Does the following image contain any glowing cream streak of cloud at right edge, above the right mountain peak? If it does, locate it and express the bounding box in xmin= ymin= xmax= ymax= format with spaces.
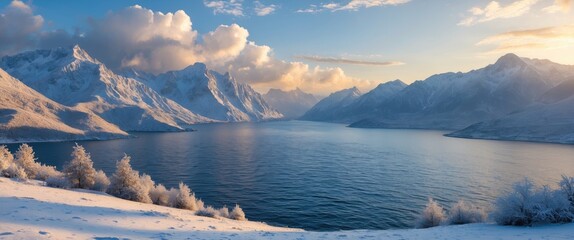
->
xmin=477 ymin=25 xmax=574 ymax=54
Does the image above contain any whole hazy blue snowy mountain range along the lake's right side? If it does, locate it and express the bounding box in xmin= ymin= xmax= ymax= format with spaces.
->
xmin=301 ymin=54 xmax=574 ymax=142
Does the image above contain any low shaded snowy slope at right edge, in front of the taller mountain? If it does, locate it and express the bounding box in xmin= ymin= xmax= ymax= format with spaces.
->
xmin=447 ymin=76 xmax=574 ymax=143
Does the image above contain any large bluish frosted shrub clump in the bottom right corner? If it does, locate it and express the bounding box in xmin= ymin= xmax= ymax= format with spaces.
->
xmin=492 ymin=179 xmax=574 ymax=226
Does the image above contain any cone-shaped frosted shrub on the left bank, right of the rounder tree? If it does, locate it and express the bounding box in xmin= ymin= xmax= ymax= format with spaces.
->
xmin=108 ymin=155 xmax=151 ymax=203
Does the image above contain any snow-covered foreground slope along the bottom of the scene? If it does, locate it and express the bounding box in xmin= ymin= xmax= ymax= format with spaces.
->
xmin=0 ymin=178 xmax=574 ymax=239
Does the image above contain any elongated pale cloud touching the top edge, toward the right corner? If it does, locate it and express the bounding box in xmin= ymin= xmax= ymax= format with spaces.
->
xmin=458 ymin=0 xmax=539 ymax=26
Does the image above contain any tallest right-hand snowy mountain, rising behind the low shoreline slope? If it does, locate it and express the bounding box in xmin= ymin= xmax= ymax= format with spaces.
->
xmin=351 ymin=54 xmax=574 ymax=130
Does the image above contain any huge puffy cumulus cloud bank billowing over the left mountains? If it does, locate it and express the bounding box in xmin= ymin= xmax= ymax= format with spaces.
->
xmin=0 ymin=1 xmax=376 ymax=94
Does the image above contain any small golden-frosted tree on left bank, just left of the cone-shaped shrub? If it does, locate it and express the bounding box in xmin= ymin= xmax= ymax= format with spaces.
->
xmin=64 ymin=144 xmax=96 ymax=189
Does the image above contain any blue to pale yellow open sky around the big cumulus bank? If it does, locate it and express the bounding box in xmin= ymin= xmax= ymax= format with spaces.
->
xmin=1 ymin=0 xmax=574 ymax=94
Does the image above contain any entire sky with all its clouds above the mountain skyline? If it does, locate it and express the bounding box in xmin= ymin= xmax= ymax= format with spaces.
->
xmin=0 ymin=0 xmax=574 ymax=95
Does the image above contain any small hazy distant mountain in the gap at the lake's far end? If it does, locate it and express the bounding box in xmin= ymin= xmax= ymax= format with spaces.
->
xmin=263 ymin=88 xmax=319 ymax=119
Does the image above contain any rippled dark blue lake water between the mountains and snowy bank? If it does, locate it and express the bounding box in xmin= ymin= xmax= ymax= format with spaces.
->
xmin=9 ymin=121 xmax=574 ymax=231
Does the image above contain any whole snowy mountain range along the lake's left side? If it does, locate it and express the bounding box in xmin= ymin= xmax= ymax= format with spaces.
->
xmin=0 ymin=45 xmax=282 ymax=142
